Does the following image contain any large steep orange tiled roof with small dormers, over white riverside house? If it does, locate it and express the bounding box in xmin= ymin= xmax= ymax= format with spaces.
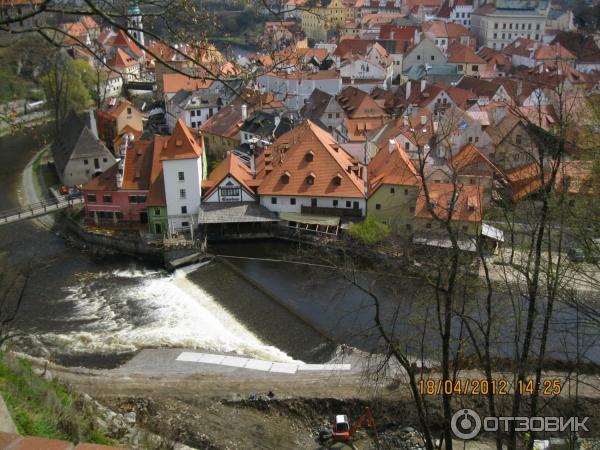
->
xmin=258 ymin=120 xmax=365 ymax=198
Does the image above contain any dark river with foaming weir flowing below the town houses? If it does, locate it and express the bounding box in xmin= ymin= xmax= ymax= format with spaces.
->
xmin=0 ymin=128 xmax=600 ymax=367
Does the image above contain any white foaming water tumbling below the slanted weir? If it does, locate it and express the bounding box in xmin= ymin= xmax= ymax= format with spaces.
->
xmin=31 ymin=265 xmax=293 ymax=362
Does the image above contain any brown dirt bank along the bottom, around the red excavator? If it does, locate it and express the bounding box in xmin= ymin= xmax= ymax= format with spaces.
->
xmin=32 ymin=358 xmax=600 ymax=450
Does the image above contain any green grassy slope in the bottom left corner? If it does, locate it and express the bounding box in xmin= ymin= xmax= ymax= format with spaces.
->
xmin=0 ymin=354 xmax=115 ymax=445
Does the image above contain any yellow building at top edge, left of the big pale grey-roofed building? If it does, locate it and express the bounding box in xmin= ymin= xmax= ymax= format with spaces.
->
xmin=302 ymin=0 xmax=347 ymax=41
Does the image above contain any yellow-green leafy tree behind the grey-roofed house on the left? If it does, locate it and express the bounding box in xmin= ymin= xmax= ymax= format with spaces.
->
xmin=41 ymin=53 xmax=94 ymax=133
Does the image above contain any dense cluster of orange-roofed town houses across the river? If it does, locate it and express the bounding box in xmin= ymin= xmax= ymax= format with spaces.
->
xmin=25 ymin=0 xmax=600 ymax=253
